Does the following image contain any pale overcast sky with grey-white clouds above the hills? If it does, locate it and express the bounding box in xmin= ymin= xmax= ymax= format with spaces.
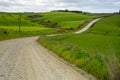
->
xmin=0 ymin=0 xmax=120 ymax=13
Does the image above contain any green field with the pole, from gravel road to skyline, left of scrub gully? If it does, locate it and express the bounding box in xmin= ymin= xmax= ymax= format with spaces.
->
xmin=0 ymin=13 xmax=57 ymax=40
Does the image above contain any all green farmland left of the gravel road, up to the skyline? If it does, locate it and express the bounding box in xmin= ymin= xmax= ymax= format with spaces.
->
xmin=0 ymin=12 xmax=96 ymax=40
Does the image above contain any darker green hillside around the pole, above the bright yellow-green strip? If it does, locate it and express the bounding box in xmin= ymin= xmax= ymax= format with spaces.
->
xmin=0 ymin=13 xmax=40 ymax=26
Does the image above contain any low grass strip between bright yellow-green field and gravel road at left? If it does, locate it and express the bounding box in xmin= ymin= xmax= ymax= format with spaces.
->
xmin=0 ymin=29 xmax=57 ymax=41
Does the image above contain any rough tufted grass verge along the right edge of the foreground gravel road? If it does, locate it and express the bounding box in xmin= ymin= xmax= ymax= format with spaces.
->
xmin=39 ymin=34 xmax=109 ymax=80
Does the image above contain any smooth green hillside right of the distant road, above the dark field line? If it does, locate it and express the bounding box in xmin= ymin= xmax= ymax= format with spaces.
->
xmin=88 ymin=15 xmax=120 ymax=36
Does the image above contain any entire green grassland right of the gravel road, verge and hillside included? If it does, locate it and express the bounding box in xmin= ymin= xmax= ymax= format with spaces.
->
xmin=39 ymin=15 xmax=120 ymax=80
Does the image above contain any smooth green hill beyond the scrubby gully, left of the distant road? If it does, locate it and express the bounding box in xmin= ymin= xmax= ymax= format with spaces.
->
xmin=29 ymin=12 xmax=96 ymax=28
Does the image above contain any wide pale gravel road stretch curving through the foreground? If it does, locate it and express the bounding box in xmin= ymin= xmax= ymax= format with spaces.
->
xmin=0 ymin=37 xmax=95 ymax=80
